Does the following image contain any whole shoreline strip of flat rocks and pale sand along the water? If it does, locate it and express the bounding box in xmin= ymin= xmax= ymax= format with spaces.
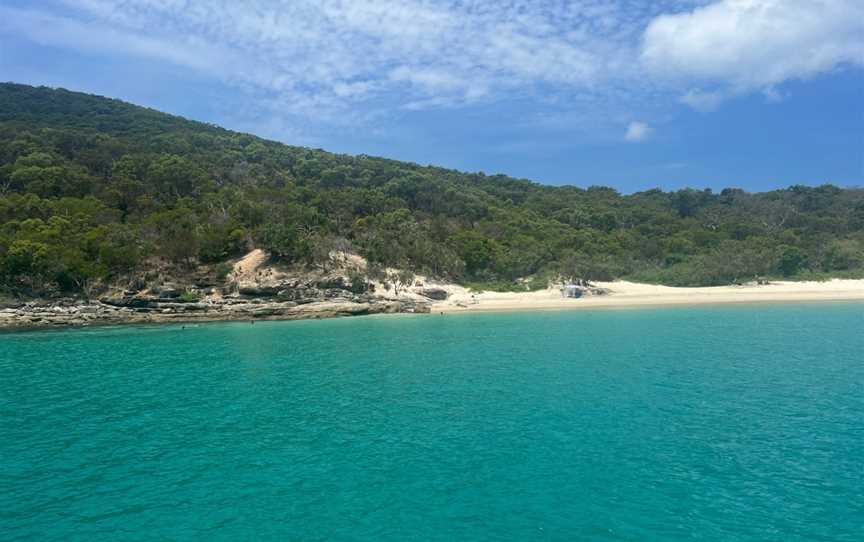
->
xmin=0 ymin=279 xmax=864 ymax=332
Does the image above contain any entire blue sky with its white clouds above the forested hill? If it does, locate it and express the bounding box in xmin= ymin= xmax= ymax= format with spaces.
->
xmin=0 ymin=0 xmax=864 ymax=192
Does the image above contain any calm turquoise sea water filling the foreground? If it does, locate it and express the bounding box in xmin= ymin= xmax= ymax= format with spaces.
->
xmin=0 ymin=304 xmax=864 ymax=542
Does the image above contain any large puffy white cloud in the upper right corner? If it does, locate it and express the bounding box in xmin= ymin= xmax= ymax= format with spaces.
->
xmin=641 ymin=0 xmax=864 ymax=110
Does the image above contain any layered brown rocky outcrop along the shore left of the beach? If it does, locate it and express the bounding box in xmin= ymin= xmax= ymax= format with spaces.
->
xmin=0 ymin=260 xmax=438 ymax=329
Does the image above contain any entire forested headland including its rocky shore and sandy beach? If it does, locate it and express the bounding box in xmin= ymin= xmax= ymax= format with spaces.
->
xmin=0 ymin=83 xmax=864 ymax=327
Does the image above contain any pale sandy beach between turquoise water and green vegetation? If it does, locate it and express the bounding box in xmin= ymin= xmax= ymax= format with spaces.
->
xmin=432 ymin=279 xmax=864 ymax=313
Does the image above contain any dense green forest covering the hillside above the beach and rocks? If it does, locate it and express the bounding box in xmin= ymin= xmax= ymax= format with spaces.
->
xmin=0 ymin=84 xmax=864 ymax=295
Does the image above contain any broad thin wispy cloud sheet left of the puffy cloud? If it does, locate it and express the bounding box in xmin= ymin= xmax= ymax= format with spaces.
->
xmin=0 ymin=0 xmax=700 ymax=117
